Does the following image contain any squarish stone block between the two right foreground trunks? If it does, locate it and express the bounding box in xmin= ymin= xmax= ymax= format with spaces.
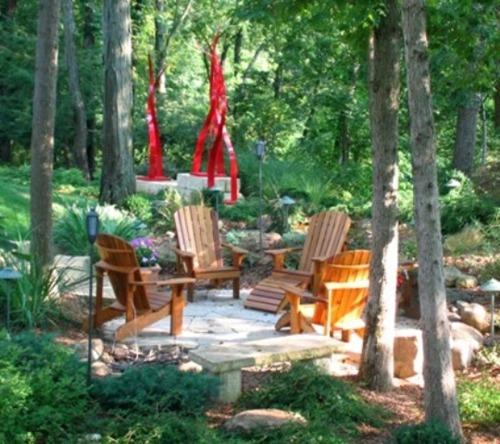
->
xmin=394 ymin=329 xmax=424 ymax=379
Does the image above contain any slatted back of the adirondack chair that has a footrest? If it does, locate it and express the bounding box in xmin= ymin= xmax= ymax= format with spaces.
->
xmin=298 ymin=211 xmax=351 ymax=273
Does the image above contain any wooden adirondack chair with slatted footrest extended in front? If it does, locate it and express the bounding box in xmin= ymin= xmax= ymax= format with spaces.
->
xmin=244 ymin=211 xmax=351 ymax=313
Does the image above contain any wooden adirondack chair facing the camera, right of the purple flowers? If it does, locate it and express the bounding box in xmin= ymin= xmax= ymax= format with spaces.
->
xmin=174 ymin=205 xmax=248 ymax=302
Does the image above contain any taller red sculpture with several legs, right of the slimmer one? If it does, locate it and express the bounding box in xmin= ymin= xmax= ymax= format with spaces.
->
xmin=191 ymin=34 xmax=238 ymax=204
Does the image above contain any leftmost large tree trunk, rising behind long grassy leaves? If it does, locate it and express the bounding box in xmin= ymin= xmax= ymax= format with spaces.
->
xmin=30 ymin=0 xmax=60 ymax=268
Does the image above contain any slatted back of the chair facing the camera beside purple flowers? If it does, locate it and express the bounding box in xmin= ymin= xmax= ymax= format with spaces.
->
xmin=174 ymin=205 xmax=224 ymax=269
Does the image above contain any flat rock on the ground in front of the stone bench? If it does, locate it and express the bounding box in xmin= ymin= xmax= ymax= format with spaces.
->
xmin=224 ymin=409 xmax=307 ymax=432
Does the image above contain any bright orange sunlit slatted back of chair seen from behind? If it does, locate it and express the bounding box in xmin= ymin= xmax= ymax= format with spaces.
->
xmin=313 ymin=250 xmax=371 ymax=325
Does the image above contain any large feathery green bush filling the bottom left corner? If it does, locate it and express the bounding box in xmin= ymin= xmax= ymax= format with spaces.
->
xmin=0 ymin=334 xmax=95 ymax=443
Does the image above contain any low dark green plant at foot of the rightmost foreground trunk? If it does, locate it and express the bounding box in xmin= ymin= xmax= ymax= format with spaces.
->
xmin=390 ymin=421 xmax=461 ymax=444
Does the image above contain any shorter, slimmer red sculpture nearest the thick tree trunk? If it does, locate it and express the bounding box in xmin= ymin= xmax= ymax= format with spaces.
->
xmin=140 ymin=56 xmax=170 ymax=181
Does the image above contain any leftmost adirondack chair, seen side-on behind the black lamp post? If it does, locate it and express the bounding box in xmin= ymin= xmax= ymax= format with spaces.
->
xmin=84 ymin=234 xmax=194 ymax=341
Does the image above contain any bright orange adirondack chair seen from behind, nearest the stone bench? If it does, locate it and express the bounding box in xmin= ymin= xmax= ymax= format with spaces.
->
xmin=275 ymin=250 xmax=370 ymax=342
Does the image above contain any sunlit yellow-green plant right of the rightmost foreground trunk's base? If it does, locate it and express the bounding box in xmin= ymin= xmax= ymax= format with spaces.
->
xmin=457 ymin=376 xmax=500 ymax=425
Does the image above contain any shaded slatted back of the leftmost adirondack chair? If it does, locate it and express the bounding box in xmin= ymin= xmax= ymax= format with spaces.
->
xmin=95 ymin=234 xmax=150 ymax=310
